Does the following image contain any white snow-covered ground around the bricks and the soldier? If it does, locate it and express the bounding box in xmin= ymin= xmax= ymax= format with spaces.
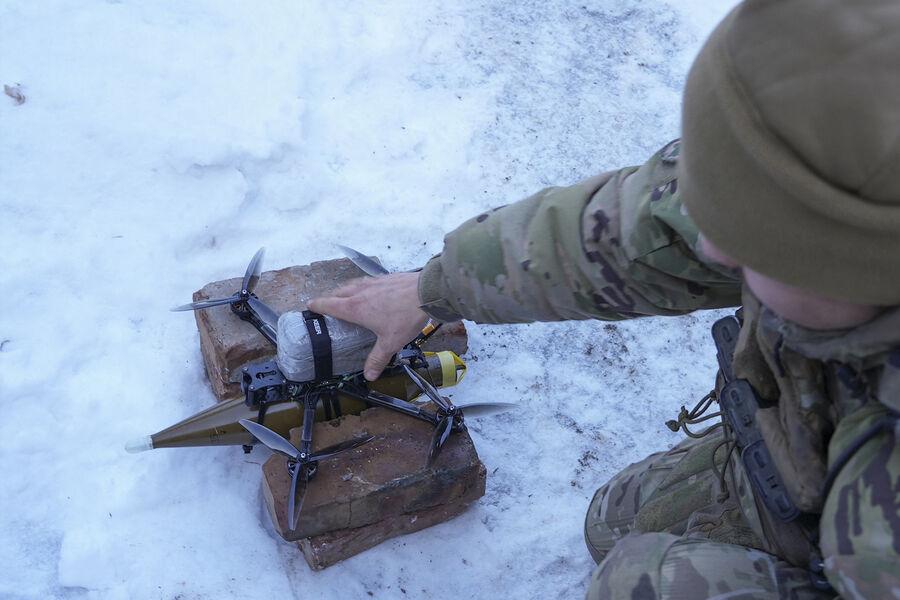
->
xmin=0 ymin=0 xmax=733 ymax=599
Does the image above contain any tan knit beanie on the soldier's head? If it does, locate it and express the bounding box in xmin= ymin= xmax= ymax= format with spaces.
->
xmin=679 ymin=0 xmax=900 ymax=305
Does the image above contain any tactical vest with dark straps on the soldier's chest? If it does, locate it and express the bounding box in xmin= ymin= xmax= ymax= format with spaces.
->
xmin=716 ymin=288 xmax=900 ymax=566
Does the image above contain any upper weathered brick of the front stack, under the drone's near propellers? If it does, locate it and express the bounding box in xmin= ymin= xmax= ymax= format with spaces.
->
xmin=263 ymin=408 xmax=485 ymax=544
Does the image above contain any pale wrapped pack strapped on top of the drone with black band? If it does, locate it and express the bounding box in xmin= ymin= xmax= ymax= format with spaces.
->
xmin=276 ymin=311 xmax=376 ymax=381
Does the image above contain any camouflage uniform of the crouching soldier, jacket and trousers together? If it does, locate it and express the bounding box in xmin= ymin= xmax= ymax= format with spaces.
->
xmin=419 ymin=141 xmax=900 ymax=598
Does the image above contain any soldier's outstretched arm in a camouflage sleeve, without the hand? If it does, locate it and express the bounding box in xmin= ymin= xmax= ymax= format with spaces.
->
xmin=419 ymin=141 xmax=740 ymax=323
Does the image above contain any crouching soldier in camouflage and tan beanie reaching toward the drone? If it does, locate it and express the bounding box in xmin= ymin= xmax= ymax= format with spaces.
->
xmin=311 ymin=0 xmax=900 ymax=599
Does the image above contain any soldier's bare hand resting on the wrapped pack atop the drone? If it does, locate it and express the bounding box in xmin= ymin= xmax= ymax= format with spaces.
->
xmin=309 ymin=273 xmax=428 ymax=381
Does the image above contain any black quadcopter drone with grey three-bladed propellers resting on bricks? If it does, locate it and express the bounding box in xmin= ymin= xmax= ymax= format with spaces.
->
xmin=172 ymin=245 xmax=516 ymax=530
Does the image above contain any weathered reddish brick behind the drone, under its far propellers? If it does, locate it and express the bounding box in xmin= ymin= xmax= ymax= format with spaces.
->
xmin=194 ymin=258 xmax=468 ymax=401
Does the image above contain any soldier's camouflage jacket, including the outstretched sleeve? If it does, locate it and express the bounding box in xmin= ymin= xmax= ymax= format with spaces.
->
xmin=419 ymin=140 xmax=900 ymax=598
